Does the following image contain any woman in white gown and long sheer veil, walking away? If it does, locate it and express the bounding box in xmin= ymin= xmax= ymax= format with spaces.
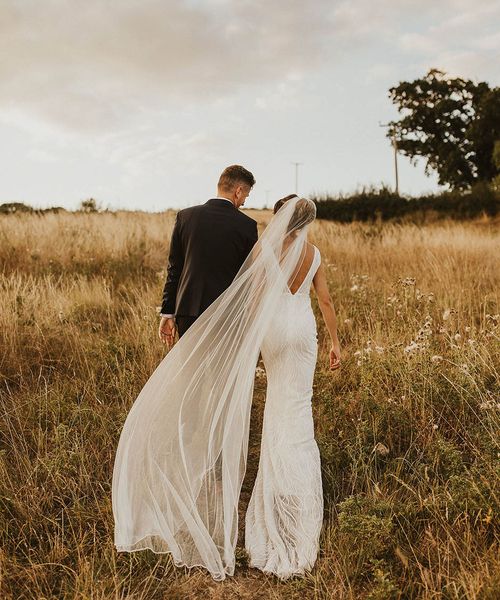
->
xmin=112 ymin=195 xmax=340 ymax=581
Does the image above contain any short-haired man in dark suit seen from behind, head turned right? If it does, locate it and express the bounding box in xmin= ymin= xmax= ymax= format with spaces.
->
xmin=158 ymin=165 xmax=257 ymax=347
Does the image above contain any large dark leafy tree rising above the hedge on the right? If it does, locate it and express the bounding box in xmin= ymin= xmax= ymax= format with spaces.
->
xmin=387 ymin=69 xmax=500 ymax=190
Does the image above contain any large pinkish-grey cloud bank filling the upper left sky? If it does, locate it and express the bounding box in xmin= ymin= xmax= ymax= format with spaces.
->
xmin=0 ymin=0 xmax=336 ymax=132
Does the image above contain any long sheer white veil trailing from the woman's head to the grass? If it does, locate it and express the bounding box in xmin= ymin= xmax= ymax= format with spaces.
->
xmin=112 ymin=197 xmax=316 ymax=580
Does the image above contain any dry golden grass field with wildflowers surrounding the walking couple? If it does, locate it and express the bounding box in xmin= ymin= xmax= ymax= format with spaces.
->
xmin=0 ymin=211 xmax=500 ymax=600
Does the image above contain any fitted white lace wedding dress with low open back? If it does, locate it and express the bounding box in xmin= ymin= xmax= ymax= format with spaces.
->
xmin=245 ymin=246 xmax=323 ymax=579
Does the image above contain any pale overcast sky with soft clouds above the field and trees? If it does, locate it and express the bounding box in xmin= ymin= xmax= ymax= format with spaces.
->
xmin=0 ymin=0 xmax=500 ymax=210
